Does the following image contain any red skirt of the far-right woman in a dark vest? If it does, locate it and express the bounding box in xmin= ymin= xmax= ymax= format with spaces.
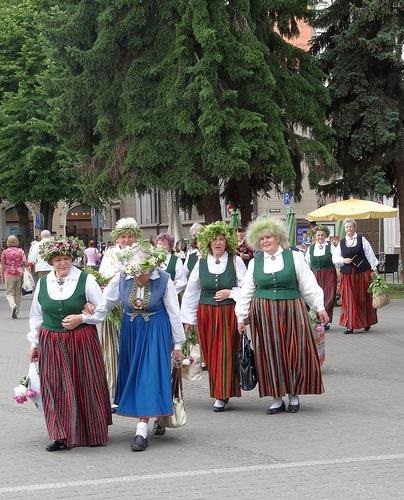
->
xmin=339 ymin=269 xmax=377 ymax=329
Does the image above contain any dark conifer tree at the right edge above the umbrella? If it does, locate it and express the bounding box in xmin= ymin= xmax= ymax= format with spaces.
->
xmin=314 ymin=0 xmax=404 ymax=262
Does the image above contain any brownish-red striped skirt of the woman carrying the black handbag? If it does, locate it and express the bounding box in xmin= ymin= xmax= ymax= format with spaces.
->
xmin=250 ymin=298 xmax=324 ymax=398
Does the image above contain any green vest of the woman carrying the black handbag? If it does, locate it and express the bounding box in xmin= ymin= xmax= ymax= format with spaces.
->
xmin=253 ymin=250 xmax=300 ymax=300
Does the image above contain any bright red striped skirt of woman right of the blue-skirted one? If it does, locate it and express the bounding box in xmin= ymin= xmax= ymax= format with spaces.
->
xmin=197 ymin=304 xmax=241 ymax=399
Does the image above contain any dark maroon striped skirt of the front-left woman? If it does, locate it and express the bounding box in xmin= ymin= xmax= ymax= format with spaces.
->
xmin=39 ymin=325 xmax=112 ymax=448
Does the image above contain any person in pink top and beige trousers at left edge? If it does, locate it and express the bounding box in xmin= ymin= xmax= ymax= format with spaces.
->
xmin=0 ymin=235 xmax=27 ymax=319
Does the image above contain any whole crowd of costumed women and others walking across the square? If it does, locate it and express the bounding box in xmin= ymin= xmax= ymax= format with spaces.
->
xmin=1 ymin=216 xmax=378 ymax=451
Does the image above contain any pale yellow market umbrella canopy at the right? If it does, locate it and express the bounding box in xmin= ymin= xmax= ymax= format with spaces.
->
xmin=307 ymin=198 xmax=398 ymax=221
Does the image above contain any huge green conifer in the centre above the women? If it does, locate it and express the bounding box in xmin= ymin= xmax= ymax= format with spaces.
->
xmin=53 ymin=0 xmax=333 ymax=220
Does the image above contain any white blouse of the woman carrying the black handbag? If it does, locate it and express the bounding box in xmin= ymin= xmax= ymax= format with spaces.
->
xmin=236 ymin=247 xmax=324 ymax=322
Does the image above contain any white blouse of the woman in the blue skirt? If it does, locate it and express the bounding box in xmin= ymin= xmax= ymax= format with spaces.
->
xmin=103 ymin=271 xmax=185 ymax=349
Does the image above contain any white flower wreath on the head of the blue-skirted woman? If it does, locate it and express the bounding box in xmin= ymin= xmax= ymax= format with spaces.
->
xmin=117 ymin=240 xmax=168 ymax=276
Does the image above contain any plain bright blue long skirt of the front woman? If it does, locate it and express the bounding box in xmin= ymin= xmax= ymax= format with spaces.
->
xmin=114 ymin=309 xmax=173 ymax=418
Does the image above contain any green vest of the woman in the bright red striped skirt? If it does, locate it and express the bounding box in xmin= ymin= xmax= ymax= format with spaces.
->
xmin=199 ymin=254 xmax=237 ymax=306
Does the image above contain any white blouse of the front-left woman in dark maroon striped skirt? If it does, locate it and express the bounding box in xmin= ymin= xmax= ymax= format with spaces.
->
xmin=27 ymin=266 xmax=107 ymax=347
